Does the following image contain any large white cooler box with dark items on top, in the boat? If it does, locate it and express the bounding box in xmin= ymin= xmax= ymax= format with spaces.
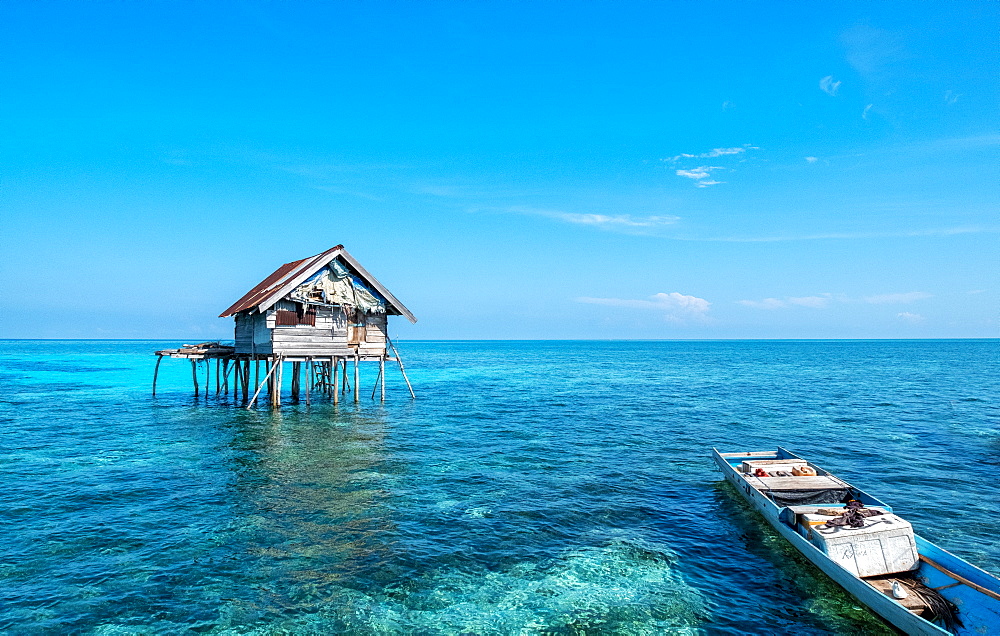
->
xmin=809 ymin=513 xmax=920 ymax=576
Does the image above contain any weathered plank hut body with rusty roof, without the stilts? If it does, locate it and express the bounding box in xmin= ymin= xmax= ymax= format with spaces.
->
xmin=220 ymin=245 xmax=417 ymax=360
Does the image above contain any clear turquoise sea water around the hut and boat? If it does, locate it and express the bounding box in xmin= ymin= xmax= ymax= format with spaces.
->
xmin=0 ymin=340 xmax=1000 ymax=634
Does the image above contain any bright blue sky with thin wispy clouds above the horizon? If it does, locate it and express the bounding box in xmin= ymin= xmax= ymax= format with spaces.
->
xmin=0 ymin=1 xmax=1000 ymax=339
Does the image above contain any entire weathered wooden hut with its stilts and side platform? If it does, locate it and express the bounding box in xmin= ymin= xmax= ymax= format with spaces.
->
xmin=154 ymin=245 xmax=417 ymax=405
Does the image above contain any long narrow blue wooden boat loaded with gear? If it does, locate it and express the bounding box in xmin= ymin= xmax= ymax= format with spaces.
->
xmin=713 ymin=447 xmax=1000 ymax=636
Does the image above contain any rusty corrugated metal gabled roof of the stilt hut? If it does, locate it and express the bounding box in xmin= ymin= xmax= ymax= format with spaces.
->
xmin=219 ymin=245 xmax=417 ymax=322
